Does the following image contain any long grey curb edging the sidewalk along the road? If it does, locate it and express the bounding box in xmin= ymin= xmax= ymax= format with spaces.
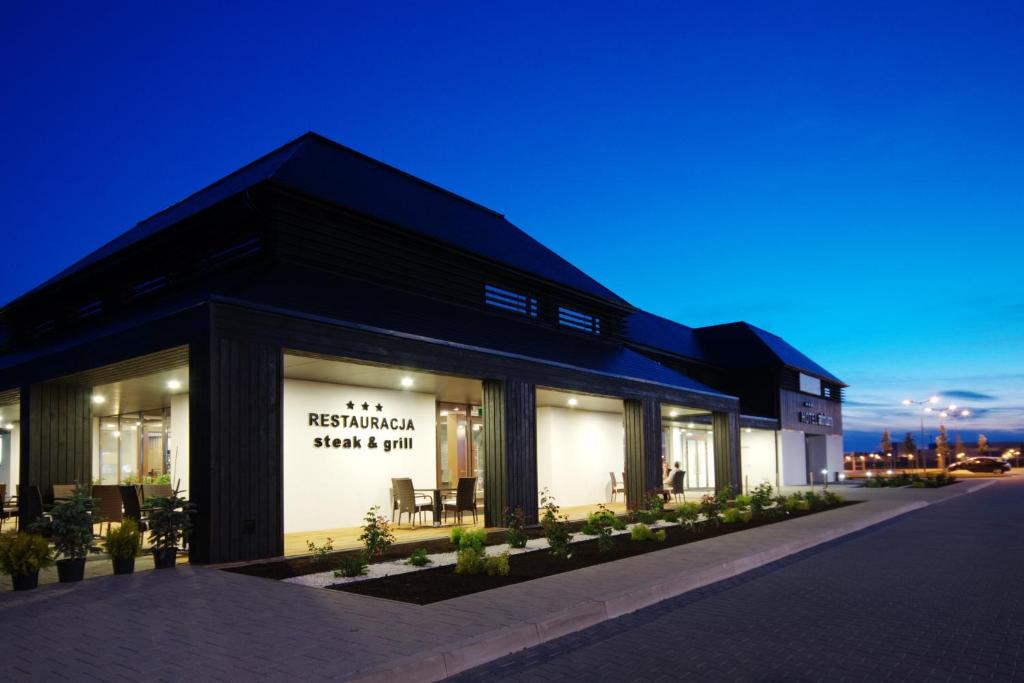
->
xmin=349 ymin=480 xmax=995 ymax=683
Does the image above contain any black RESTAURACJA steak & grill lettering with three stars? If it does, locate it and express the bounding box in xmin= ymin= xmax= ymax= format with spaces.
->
xmin=306 ymin=400 xmax=416 ymax=453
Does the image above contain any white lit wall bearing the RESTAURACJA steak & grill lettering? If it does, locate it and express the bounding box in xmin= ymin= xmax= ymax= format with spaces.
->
xmin=284 ymin=379 xmax=438 ymax=533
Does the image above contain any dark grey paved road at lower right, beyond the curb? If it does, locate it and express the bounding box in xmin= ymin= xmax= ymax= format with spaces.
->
xmin=456 ymin=476 xmax=1024 ymax=682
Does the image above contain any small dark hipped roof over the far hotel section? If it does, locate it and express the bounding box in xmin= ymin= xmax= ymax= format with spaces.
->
xmin=694 ymin=323 xmax=846 ymax=386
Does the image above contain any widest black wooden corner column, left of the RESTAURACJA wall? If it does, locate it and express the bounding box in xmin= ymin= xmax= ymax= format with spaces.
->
xmin=188 ymin=334 xmax=282 ymax=562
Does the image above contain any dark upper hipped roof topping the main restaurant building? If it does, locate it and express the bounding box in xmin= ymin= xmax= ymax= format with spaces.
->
xmin=16 ymin=132 xmax=629 ymax=306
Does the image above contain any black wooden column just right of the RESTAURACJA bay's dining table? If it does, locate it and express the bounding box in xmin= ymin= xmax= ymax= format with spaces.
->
xmin=482 ymin=379 xmax=538 ymax=526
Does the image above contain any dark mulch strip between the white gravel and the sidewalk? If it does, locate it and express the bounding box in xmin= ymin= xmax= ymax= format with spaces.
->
xmin=328 ymin=502 xmax=855 ymax=605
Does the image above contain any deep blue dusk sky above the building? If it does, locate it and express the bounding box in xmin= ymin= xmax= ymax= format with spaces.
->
xmin=0 ymin=1 xmax=1024 ymax=447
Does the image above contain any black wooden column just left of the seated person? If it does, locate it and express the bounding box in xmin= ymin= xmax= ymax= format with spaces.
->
xmin=623 ymin=398 xmax=662 ymax=510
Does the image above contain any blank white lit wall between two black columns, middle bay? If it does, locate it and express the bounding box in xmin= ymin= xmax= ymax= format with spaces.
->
xmin=537 ymin=408 xmax=626 ymax=506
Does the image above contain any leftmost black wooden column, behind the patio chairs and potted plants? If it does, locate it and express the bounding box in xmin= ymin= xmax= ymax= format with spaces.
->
xmin=19 ymin=383 xmax=92 ymax=511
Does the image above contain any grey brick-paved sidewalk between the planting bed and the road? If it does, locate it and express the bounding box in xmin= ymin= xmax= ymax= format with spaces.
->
xmin=0 ymin=482 xmax=991 ymax=681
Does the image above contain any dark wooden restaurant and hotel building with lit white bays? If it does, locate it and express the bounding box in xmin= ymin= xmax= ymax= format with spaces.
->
xmin=0 ymin=133 xmax=844 ymax=562
